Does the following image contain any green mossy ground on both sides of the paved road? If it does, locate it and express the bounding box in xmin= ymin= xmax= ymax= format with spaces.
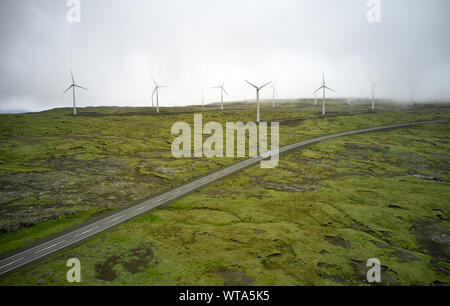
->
xmin=0 ymin=101 xmax=450 ymax=285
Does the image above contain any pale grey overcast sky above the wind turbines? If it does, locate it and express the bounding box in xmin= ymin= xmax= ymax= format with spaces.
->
xmin=0 ymin=0 xmax=450 ymax=111
